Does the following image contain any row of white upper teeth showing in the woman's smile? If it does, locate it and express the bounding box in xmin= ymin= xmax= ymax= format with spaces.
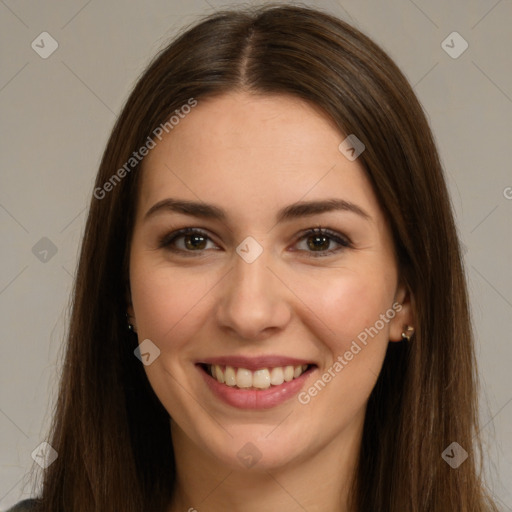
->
xmin=208 ymin=364 xmax=308 ymax=389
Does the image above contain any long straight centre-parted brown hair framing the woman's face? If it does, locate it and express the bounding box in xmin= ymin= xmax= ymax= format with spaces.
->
xmin=27 ymin=5 xmax=496 ymax=512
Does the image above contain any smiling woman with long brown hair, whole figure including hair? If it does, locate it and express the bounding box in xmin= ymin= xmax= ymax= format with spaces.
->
xmin=9 ymin=6 xmax=496 ymax=512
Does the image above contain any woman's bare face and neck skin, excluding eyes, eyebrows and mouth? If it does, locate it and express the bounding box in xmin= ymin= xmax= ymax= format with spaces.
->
xmin=128 ymin=92 xmax=414 ymax=512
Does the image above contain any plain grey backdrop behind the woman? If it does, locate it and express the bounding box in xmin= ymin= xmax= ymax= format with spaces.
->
xmin=0 ymin=0 xmax=512 ymax=511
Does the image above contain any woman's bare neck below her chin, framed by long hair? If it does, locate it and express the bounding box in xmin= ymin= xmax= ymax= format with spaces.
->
xmin=168 ymin=411 xmax=364 ymax=512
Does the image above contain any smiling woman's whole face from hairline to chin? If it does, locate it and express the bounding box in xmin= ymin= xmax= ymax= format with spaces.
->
xmin=129 ymin=93 xmax=411 ymax=469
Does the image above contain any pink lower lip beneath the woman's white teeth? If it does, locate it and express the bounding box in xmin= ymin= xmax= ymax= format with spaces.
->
xmin=198 ymin=365 xmax=315 ymax=409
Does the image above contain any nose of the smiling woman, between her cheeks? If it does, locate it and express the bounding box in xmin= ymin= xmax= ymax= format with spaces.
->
xmin=216 ymin=243 xmax=291 ymax=341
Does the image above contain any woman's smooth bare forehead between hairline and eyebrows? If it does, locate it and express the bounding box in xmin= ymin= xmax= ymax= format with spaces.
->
xmin=138 ymin=93 xmax=378 ymax=224
